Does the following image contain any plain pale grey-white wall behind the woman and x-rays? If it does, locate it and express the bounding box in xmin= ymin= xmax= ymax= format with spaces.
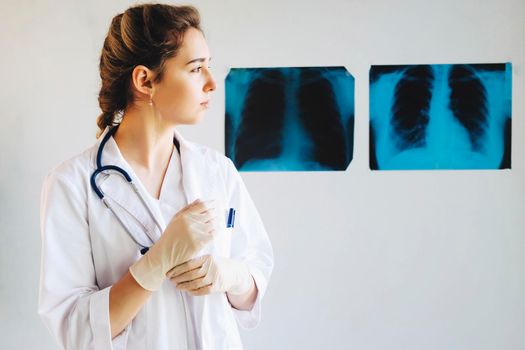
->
xmin=0 ymin=0 xmax=525 ymax=350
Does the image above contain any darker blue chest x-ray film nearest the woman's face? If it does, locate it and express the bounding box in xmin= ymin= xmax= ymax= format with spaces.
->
xmin=225 ymin=67 xmax=354 ymax=171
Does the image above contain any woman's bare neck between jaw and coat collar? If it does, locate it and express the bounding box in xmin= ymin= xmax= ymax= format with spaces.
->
xmin=113 ymin=109 xmax=174 ymax=171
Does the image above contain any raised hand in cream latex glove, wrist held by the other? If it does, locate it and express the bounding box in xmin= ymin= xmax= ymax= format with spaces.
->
xmin=129 ymin=200 xmax=220 ymax=291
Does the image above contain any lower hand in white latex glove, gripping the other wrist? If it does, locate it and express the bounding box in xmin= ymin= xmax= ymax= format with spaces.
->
xmin=167 ymin=255 xmax=255 ymax=295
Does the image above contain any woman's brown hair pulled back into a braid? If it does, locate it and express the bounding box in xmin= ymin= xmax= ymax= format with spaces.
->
xmin=97 ymin=4 xmax=202 ymax=137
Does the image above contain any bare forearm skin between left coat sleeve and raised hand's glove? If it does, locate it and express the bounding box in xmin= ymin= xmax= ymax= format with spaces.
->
xmin=109 ymin=271 xmax=152 ymax=338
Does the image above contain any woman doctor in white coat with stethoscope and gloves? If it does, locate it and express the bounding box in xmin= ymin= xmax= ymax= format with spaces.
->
xmin=38 ymin=4 xmax=273 ymax=350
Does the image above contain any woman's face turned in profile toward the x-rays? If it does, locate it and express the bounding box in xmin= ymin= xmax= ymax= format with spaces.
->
xmin=153 ymin=28 xmax=216 ymax=124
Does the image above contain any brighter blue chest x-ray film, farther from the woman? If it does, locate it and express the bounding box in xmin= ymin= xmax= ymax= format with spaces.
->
xmin=370 ymin=63 xmax=512 ymax=170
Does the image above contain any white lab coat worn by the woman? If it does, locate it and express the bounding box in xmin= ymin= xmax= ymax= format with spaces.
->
xmin=38 ymin=129 xmax=273 ymax=350
